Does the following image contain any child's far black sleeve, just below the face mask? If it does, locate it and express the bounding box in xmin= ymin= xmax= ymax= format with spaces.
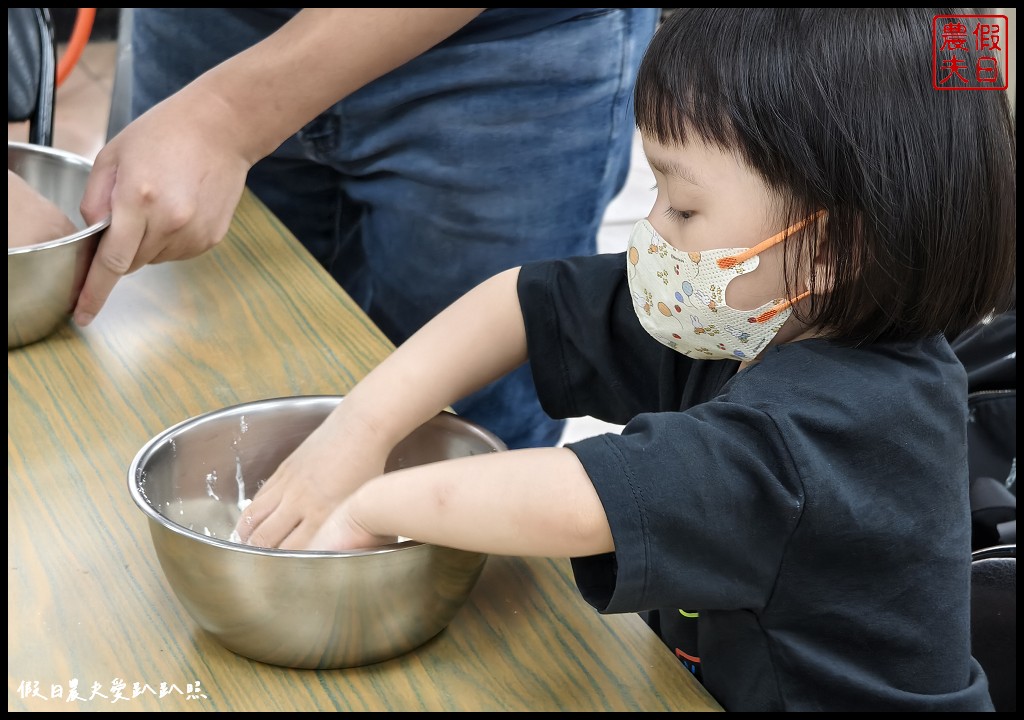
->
xmin=518 ymin=253 xmax=692 ymax=424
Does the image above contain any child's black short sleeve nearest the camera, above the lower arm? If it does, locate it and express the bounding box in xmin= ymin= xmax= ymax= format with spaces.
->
xmin=567 ymin=401 xmax=804 ymax=612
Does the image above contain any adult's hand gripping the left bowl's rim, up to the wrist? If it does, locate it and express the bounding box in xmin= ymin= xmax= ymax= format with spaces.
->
xmin=74 ymin=87 xmax=255 ymax=326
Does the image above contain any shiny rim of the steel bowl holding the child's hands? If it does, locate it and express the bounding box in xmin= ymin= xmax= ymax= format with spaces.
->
xmin=128 ymin=394 xmax=506 ymax=559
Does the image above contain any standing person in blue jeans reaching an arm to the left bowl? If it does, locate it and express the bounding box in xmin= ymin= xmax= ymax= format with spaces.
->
xmin=75 ymin=8 xmax=659 ymax=448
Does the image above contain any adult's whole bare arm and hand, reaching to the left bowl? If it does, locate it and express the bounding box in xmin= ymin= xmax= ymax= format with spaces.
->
xmin=74 ymin=7 xmax=483 ymax=326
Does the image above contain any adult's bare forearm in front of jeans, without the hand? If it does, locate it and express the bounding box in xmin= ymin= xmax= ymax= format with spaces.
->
xmin=188 ymin=7 xmax=483 ymax=163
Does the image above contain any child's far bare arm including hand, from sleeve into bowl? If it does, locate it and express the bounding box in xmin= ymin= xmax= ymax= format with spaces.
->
xmin=238 ymin=270 xmax=526 ymax=549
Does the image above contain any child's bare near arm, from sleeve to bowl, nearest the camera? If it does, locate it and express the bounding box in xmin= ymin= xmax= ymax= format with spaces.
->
xmin=344 ymin=448 xmax=614 ymax=557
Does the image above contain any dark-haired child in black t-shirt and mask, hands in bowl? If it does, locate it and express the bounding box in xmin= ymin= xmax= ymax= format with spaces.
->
xmin=239 ymin=8 xmax=1016 ymax=711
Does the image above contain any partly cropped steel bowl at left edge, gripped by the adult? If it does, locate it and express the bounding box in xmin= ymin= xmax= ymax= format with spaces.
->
xmin=7 ymin=140 xmax=111 ymax=350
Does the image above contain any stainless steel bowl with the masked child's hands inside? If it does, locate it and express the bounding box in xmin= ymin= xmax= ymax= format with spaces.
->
xmin=128 ymin=395 xmax=506 ymax=669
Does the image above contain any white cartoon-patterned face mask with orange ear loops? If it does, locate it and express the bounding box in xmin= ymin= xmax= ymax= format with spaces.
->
xmin=626 ymin=213 xmax=822 ymax=361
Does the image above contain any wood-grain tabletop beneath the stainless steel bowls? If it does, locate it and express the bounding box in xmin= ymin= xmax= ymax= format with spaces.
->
xmin=7 ymin=193 xmax=720 ymax=712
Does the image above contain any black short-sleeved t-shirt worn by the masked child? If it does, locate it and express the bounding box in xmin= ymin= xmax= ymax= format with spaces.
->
xmin=519 ymin=255 xmax=991 ymax=711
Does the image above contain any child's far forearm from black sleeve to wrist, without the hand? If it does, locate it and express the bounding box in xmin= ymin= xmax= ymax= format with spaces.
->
xmin=329 ymin=268 xmax=526 ymax=446
